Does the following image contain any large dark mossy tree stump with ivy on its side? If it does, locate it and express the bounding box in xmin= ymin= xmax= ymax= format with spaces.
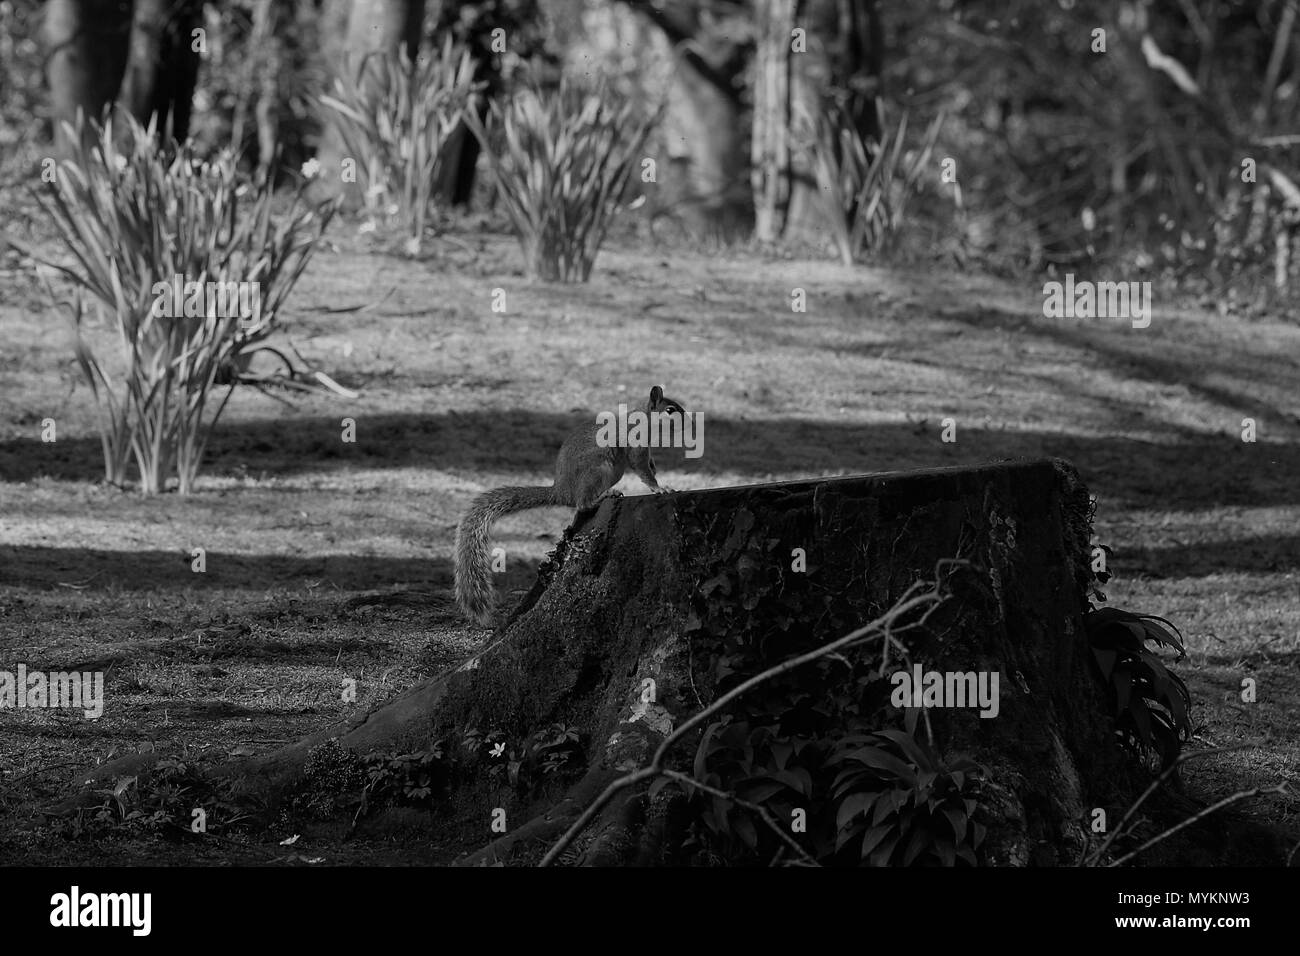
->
xmin=208 ymin=460 xmax=1117 ymax=865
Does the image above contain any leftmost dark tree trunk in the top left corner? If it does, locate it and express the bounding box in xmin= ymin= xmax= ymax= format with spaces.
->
xmin=42 ymin=0 xmax=131 ymax=152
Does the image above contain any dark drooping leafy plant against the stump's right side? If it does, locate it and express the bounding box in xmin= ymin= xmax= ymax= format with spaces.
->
xmin=1084 ymin=607 xmax=1192 ymax=767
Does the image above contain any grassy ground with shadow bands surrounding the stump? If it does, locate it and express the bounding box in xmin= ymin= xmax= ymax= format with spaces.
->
xmin=0 ymin=214 xmax=1300 ymax=864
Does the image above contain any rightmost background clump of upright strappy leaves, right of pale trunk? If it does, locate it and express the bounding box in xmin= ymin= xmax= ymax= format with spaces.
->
xmin=810 ymin=104 xmax=944 ymax=265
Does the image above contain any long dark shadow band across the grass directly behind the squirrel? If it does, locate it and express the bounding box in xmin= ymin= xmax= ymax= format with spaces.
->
xmin=0 ymin=412 xmax=1300 ymax=514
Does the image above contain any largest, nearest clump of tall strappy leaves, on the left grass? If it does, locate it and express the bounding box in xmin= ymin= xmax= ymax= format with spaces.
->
xmin=31 ymin=116 xmax=334 ymax=494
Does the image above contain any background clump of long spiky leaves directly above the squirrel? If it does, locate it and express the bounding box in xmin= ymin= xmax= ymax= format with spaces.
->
xmin=465 ymin=79 xmax=654 ymax=282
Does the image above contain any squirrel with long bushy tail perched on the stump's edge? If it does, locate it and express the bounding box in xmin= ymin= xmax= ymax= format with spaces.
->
xmin=456 ymin=385 xmax=685 ymax=627
